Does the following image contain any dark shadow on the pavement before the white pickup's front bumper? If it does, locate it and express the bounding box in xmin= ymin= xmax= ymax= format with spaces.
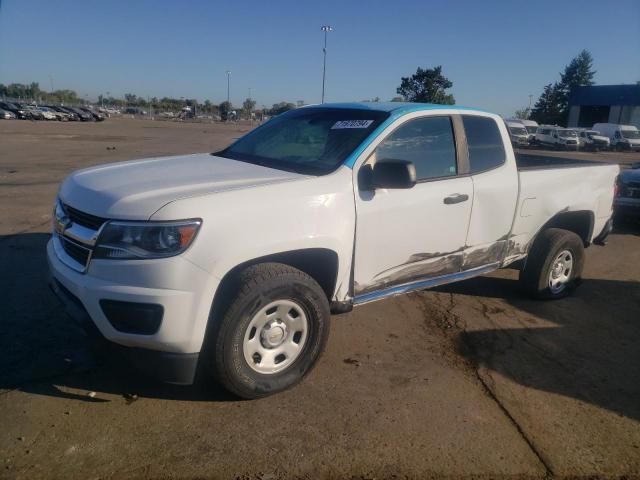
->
xmin=0 ymin=233 xmax=234 ymax=402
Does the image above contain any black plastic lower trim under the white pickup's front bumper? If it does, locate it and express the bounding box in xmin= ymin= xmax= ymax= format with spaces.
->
xmin=49 ymin=277 xmax=200 ymax=385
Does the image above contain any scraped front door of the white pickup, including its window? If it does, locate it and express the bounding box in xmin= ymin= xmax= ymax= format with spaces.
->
xmin=354 ymin=114 xmax=473 ymax=296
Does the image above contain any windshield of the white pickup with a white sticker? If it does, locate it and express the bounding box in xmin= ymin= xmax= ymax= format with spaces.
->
xmin=215 ymin=107 xmax=389 ymax=175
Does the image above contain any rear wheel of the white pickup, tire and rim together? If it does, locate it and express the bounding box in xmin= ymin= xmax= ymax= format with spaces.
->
xmin=520 ymin=228 xmax=584 ymax=299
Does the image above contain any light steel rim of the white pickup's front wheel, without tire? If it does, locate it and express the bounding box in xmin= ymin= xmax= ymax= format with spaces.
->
xmin=242 ymin=300 xmax=309 ymax=375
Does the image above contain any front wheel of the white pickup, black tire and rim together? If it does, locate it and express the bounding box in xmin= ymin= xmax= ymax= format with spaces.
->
xmin=209 ymin=263 xmax=330 ymax=399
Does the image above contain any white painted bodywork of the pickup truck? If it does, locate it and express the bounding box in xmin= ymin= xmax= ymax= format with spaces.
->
xmin=47 ymin=107 xmax=618 ymax=353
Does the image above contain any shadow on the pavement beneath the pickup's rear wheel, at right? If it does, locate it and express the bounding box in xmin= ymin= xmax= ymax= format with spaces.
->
xmin=438 ymin=277 xmax=640 ymax=420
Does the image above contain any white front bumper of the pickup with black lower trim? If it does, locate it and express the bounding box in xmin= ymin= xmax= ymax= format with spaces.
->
xmin=47 ymin=236 xmax=217 ymax=383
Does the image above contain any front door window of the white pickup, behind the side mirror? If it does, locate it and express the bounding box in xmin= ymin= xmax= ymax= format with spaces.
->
xmin=375 ymin=117 xmax=458 ymax=180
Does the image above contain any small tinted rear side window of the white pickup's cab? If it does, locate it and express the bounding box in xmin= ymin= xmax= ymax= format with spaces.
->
xmin=462 ymin=115 xmax=506 ymax=173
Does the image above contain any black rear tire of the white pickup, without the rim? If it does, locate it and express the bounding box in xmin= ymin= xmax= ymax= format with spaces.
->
xmin=520 ymin=228 xmax=584 ymax=299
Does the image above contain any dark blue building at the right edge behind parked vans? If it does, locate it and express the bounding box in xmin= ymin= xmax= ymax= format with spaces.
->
xmin=567 ymin=82 xmax=640 ymax=128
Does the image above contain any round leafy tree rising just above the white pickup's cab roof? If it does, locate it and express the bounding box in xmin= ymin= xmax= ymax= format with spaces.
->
xmin=396 ymin=65 xmax=455 ymax=105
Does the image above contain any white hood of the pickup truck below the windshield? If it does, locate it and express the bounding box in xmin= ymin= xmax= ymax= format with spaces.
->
xmin=59 ymin=153 xmax=305 ymax=220
